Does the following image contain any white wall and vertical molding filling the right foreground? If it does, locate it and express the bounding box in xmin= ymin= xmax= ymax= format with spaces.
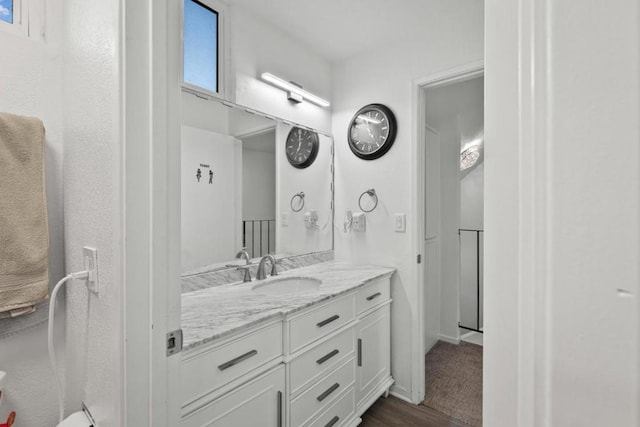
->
xmin=483 ymin=0 xmax=640 ymax=426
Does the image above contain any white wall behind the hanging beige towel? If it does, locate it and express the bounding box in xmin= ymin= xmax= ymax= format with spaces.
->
xmin=0 ymin=0 xmax=64 ymax=427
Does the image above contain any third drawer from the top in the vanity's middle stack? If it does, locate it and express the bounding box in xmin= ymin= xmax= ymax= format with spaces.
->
xmin=291 ymin=358 xmax=355 ymax=426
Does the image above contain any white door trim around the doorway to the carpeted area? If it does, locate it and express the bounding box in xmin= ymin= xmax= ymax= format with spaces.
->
xmin=411 ymin=61 xmax=485 ymax=403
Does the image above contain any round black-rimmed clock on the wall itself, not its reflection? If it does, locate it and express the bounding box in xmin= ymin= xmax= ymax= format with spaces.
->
xmin=347 ymin=104 xmax=398 ymax=160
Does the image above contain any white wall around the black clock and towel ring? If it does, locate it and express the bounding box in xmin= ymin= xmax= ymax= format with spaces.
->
xmin=332 ymin=0 xmax=483 ymax=398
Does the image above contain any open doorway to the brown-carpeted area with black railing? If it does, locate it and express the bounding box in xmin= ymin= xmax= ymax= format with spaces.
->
xmin=417 ymin=66 xmax=484 ymax=425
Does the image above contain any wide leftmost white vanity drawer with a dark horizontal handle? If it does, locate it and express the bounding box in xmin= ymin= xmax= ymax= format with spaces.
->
xmin=181 ymin=323 xmax=282 ymax=406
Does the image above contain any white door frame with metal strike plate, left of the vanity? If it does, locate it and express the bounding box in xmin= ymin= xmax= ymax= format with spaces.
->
xmin=118 ymin=0 xmax=182 ymax=427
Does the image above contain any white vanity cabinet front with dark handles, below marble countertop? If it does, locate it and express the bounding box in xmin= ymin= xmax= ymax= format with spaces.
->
xmin=181 ymin=275 xmax=393 ymax=427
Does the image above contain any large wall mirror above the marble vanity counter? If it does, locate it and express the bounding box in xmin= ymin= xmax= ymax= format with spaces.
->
xmin=181 ymin=92 xmax=333 ymax=275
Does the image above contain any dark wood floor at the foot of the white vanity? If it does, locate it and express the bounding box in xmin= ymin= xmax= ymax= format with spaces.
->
xmin=358 ymin=396 xmax=469 ymax=427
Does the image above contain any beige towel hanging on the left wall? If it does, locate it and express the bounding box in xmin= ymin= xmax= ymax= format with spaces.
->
xmin=0 ymin=113 xmax=49 ymax=318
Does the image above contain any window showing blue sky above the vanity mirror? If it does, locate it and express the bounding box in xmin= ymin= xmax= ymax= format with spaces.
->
xmin=183 ymin=0 xmax=221 ymax=94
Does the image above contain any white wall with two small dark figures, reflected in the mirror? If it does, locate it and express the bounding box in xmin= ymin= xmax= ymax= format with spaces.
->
xmin=180 ymin=126 xmax=242 ymax=272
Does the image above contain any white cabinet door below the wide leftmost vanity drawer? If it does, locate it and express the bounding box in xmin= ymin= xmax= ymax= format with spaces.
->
xmin=181 ymin=365 xmax=285 ymax=427
